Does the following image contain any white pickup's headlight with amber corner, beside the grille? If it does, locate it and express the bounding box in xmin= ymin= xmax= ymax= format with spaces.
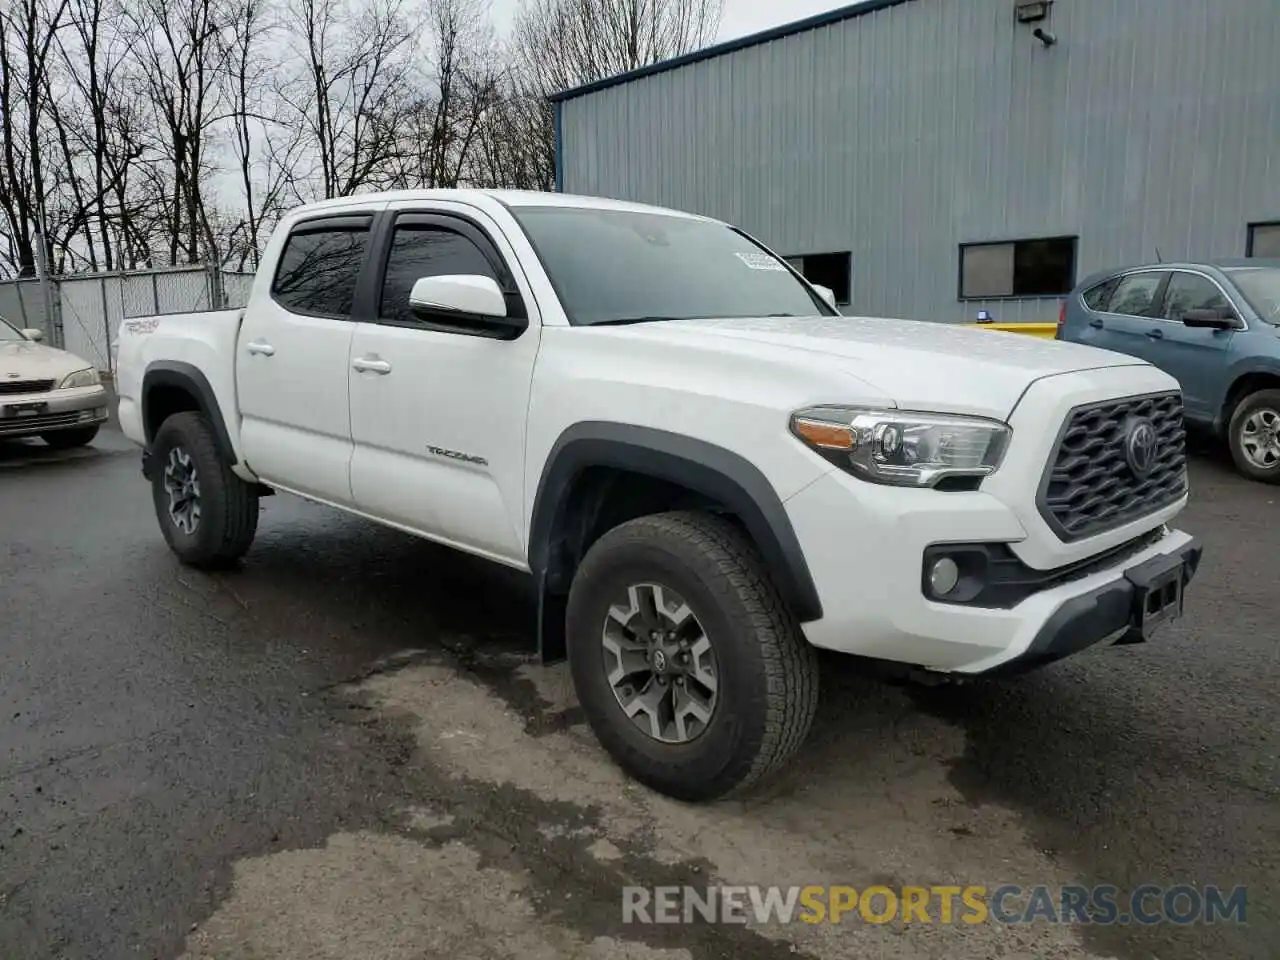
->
xmin=791 ymin=407 xmax=1010 ymax=486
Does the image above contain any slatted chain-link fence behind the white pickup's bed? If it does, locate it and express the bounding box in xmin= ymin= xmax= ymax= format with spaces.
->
xmin=0 ymin=266 xmax=253 ymax=371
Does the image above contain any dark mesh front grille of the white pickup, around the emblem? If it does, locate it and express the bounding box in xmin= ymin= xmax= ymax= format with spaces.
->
xmin=1037 ymin=392 xmax=1187 ymax=543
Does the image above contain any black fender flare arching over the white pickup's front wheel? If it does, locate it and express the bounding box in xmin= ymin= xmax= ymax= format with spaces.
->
xmin=529 ymin=421 xmax=822 ymax=622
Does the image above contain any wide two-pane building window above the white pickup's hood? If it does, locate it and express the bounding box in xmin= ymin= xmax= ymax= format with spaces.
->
xmin=960 ymin=237 xmax=1078 ymax=300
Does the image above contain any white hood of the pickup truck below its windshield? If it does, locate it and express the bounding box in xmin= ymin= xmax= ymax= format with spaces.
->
xmin=627 ymin=316 xmax=1146 ymax=419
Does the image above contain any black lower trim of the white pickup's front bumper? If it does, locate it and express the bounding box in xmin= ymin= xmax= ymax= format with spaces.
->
xmin=988 ymin=540 xmax=1203 ymax=676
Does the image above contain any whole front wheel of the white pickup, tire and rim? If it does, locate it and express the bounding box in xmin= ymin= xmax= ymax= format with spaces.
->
xmin=566 ymin=513 xmax=818 ymax=800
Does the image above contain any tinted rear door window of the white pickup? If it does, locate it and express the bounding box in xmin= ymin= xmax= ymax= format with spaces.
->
xmin=271 ymin=227 xmax=369 ymax=317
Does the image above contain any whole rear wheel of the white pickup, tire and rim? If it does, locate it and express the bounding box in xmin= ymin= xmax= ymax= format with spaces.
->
xmin=151 ymin=413 xmax=259 ymax=567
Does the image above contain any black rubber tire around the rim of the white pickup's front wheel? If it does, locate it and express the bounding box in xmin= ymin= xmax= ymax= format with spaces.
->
xmin=566 ymin=512 xmax=818 ymax=801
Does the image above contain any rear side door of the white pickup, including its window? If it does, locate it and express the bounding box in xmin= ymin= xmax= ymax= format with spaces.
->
xmin=236 ymin=211 xmax=374 ymax=504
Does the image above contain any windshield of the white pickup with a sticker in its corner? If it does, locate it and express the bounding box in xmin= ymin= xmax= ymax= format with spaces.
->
xmin=512 ymin=206 xmax=836 ymax=325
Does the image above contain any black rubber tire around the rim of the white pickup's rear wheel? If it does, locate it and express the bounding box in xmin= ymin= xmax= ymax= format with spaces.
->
xmin=151 ymin=413 xmax=259 ymax=568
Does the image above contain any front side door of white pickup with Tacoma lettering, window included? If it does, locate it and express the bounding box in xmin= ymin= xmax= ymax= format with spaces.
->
xmin=351 ymin=202 xmax=540 ymax=566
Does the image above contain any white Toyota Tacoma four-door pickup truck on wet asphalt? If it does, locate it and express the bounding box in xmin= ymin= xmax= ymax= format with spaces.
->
xmin=118 ymin=191 xmax=1201 ymax=800
